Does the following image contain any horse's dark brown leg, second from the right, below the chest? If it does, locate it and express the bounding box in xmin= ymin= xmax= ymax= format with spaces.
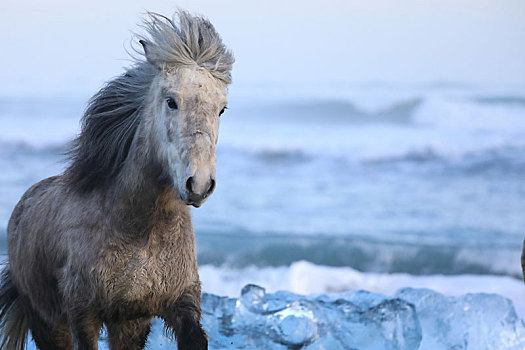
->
xmin=107 ymin=317 xmax=151 ymax=350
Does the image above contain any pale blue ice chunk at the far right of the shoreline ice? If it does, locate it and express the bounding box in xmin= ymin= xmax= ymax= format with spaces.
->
xmin=396 ymin=288 xmax=525 ymax=350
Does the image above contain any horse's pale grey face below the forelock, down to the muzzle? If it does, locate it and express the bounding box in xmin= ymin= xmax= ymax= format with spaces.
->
xmin=151 ymin=66 xmax=226 ymax=207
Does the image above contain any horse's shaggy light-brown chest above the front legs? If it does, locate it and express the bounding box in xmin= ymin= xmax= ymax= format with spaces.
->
xmin=98 ymin=227 xmax=198 ymax=310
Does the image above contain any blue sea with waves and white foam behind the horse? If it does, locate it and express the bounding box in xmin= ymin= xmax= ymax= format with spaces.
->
xmin=0 ymin=84 xmax=525 ymax=316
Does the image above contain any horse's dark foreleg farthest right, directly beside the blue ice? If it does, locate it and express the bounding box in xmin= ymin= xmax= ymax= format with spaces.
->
xmin=162 ymin=286 xmax=208 ymax=350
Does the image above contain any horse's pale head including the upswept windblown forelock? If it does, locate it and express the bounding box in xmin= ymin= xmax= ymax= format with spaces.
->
xmin=141 ymin=12 xmax=233 ymax=207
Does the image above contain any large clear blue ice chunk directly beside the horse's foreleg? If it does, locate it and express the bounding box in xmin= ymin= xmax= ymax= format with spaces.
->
xmin=203 ymin=285 xmax=421 ymax=350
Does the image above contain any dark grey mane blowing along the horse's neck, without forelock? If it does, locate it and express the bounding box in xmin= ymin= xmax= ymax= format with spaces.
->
xmin=65 ymin=62 xmax=156 ymax=192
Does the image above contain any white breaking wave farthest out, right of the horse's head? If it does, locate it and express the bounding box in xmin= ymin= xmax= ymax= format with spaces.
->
xmin=218 ymin=96 xmax=525 ymax=163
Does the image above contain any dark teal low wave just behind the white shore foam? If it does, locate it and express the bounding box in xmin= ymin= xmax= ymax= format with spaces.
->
xmin=197 ymin=233 xmax=521 ymax=277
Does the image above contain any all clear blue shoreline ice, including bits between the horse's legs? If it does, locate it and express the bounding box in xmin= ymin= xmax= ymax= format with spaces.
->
xmin=18 ymin=284 xmax=525 ymax=350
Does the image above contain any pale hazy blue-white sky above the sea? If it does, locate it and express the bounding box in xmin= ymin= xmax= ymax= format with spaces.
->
xmin=0 ymin=0 xmax=525 ymax=95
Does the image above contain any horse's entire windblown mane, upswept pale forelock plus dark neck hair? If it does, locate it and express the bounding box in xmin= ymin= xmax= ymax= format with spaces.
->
xmin=64 ymin=11 xmax=234 ymax=192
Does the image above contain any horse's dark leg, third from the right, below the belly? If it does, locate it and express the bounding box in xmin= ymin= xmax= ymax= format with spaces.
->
xmin=69 ymin=309 xmax=102 ymax=350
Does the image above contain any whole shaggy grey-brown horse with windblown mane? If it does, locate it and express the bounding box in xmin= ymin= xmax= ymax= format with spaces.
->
xmin=0 ymin=12 xmax=233 ymax=349
